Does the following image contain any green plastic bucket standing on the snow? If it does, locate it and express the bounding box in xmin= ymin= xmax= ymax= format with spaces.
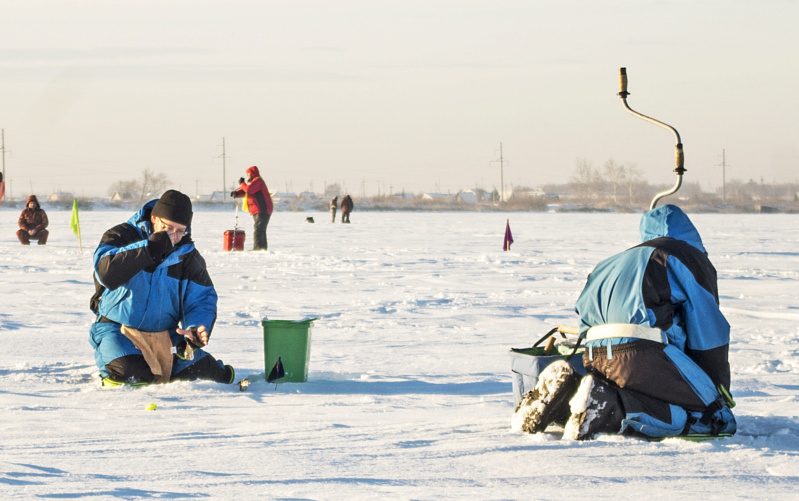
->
xmin=261 ymin=318 xmax=316 ymax=383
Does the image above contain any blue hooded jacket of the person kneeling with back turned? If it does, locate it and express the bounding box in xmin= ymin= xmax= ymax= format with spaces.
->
xmin=576 ymin=205 xmax=730 ymax=389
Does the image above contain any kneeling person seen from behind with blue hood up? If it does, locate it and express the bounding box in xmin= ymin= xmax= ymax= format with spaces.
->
xmin=514 ymin=205 xmax=736 ymax=440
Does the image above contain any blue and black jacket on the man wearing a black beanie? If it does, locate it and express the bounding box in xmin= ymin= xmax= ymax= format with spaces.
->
xmin=91 ymin=200 xmax=217 ymax=334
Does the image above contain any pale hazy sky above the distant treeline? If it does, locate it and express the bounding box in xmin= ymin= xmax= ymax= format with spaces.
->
xmin=0 ymin=0 xmax=799 ymax=197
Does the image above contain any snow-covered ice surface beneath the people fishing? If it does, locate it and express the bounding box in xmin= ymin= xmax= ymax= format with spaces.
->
xmin=0 ymin=206 xmax=799 ymax=499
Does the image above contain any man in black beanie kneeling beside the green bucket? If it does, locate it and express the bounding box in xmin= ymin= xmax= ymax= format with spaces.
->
xmin=89 ymin=190 xmax=235 ymax=386
